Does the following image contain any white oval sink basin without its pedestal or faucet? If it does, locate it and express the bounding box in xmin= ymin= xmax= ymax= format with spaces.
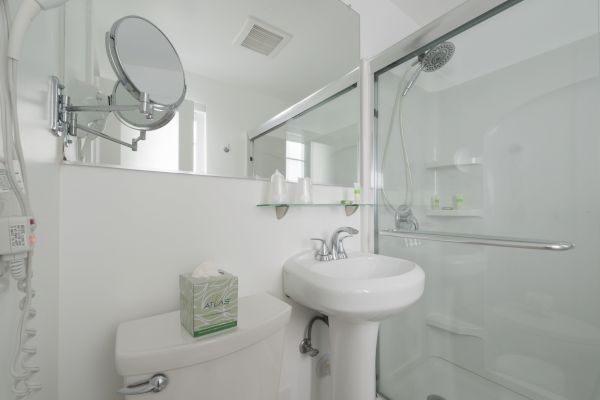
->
xmin=283 ymin=251 xmax=425 ymax=321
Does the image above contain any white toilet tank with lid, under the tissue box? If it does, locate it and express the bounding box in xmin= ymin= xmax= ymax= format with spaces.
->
xmin=115 ymin=293 xmax=291 ymax=400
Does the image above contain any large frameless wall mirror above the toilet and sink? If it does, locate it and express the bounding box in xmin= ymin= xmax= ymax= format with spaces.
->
xmin=64 ymin=0 xmax=359 ymax=184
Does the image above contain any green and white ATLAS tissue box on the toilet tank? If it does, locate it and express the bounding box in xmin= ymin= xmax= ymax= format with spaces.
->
xmin=179 ymin=270 xmax=238 ymax=337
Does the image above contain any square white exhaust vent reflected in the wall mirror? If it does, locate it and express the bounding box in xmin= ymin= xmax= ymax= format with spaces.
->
xmin=234 ymin=17 xmax=292 ymax=57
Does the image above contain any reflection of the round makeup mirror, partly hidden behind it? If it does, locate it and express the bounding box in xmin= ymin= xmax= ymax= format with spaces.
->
xmin=112 ymin=82 xmax=175 ymax=131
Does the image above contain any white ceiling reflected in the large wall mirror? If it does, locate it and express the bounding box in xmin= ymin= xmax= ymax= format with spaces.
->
xmin=66 ymin=0 xmax=360 ymax=104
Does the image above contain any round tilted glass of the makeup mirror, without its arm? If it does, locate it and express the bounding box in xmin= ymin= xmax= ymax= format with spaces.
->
xmin=106 ymin=15 xmax=186 ymax=110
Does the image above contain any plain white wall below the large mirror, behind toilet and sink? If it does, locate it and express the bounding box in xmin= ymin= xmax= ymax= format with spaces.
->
xmin=59 ymin=166 xmax=360 ymax=400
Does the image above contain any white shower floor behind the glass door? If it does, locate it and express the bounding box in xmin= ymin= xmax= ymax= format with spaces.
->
xmin=379 ymin=357 xmax=529 ymax=400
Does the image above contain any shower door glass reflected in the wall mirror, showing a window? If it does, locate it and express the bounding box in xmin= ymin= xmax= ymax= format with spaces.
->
xmin=249 ymin=84 xmax=360 ymax=186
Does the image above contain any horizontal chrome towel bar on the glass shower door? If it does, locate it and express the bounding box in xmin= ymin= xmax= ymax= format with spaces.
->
xmin=379 ymin=229 xmax=575 ymax=251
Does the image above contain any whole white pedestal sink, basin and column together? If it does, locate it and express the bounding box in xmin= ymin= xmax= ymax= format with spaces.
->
xmin=283 ymin=252 xmax=425 ymax=400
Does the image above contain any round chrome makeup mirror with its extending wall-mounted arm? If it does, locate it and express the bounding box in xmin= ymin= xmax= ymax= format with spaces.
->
xmin=50 ymin=15 xmax=186 ymax=151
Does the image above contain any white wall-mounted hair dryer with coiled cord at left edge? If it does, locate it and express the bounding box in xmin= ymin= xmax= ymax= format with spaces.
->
xmin=0 ymin=0 xmax=67 ymax=400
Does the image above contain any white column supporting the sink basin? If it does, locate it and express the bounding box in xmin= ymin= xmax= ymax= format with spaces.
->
xmin=329 ymin=316 xmax=379 ymax=400
